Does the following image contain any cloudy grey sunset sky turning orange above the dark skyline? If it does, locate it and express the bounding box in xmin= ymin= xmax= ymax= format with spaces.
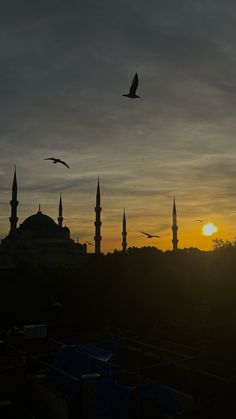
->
xmin=0 ymin=0 xmax=236 ymax=252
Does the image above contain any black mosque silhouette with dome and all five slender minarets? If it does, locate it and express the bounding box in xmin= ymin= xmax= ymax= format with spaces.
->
xmin=0 ymin=169 xmax=178 ymax=268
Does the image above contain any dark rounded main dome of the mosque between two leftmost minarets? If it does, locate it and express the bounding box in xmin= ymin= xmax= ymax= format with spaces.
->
xmin=20 ymin=211 xmax=58 ymax=233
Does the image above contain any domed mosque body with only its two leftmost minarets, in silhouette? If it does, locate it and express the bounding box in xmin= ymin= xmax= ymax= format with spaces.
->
xmin=0 ymin=169 xmax=87 ymax=267
